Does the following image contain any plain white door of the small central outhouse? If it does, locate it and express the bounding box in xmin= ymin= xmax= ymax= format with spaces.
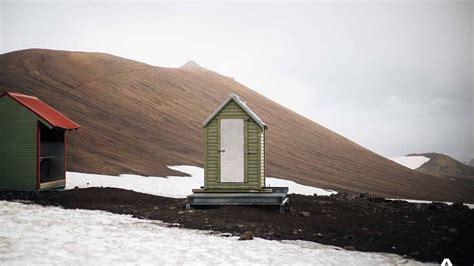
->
xmin=219 ymin=119 xmax=245 ymax=182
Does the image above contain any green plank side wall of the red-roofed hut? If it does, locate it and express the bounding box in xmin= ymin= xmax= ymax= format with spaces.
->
xmin=0 ymin=96 xmax=38 ymax=190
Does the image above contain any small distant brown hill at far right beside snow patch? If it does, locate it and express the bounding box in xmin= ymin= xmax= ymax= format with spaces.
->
xmin=408 ymin=152 xmax=474 ymax=177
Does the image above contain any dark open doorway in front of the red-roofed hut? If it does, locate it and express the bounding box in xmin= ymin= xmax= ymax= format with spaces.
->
xmin=39 ymin=123 xmax=65 ymax=183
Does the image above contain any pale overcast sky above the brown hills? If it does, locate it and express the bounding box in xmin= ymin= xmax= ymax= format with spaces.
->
xmin=0 ymin=0 xmax=474 ymax=160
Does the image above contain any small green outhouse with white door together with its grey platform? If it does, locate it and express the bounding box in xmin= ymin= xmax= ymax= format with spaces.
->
xmin=186 ymin=93 xmax=289 ymax=212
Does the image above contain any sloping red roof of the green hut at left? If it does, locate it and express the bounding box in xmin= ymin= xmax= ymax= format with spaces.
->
xmin=0 ymin=91 xmax=80 ymax=129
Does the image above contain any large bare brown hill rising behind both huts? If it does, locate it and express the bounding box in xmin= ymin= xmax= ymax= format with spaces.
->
xmin=0 ymin=49 xmax=474 ymax=202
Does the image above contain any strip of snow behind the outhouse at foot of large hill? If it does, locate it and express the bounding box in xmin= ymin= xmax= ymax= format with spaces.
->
xmin=66 ymin=165 xmax=337 ymax=198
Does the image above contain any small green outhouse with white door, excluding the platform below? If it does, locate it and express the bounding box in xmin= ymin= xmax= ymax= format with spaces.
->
xmin=202 ymin=93 xmax=266 ymax=192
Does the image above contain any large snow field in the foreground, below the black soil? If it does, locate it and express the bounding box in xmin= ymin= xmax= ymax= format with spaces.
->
xmin=0 ymin=201 xmax=422 ymax=265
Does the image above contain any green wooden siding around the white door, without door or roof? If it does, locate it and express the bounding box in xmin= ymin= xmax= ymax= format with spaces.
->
xmin=204 ymin=101 xmax=263 ymax=190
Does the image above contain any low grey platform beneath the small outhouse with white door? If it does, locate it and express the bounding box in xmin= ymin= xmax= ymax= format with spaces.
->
xmin=186 ymin=187 xmax=289 ymax=212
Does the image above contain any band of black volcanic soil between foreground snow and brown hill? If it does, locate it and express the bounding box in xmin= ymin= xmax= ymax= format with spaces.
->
xmin=0 ymin=188 xmax=474 ymax=265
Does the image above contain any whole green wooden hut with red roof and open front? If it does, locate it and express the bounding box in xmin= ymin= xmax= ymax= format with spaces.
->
xmin=0 ymin=92 xmax=79 ymax=190
